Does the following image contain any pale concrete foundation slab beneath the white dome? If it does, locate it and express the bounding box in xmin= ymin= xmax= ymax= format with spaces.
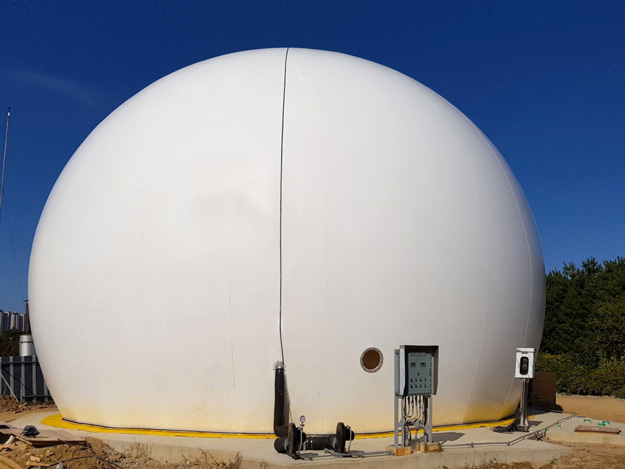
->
xmin=11 ymin=412 xmax=584 ymax=469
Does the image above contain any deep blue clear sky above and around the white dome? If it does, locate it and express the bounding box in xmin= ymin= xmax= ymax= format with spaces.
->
xmin=0 ymin=0 xmax=625 ymax=311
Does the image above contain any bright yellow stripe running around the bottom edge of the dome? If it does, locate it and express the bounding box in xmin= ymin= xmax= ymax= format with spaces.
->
xmin=41 ymin=414 xmax=534 ymax=439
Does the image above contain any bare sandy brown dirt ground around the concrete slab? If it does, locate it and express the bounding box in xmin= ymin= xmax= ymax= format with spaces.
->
xmin=0 ymin=396 xmax=625 ymax=469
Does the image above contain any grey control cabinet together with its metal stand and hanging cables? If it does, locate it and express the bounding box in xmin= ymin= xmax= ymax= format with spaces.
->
xmin=389 ymin=345 xmax=438 ymax=454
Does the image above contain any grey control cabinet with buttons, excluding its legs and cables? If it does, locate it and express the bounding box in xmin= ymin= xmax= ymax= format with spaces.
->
xmin=395 ymin=345 xmax=438 ymax=396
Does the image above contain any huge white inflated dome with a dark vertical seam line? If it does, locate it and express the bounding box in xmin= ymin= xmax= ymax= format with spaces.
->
xmin=29 ymin=49 xmax=545 ymax=433
